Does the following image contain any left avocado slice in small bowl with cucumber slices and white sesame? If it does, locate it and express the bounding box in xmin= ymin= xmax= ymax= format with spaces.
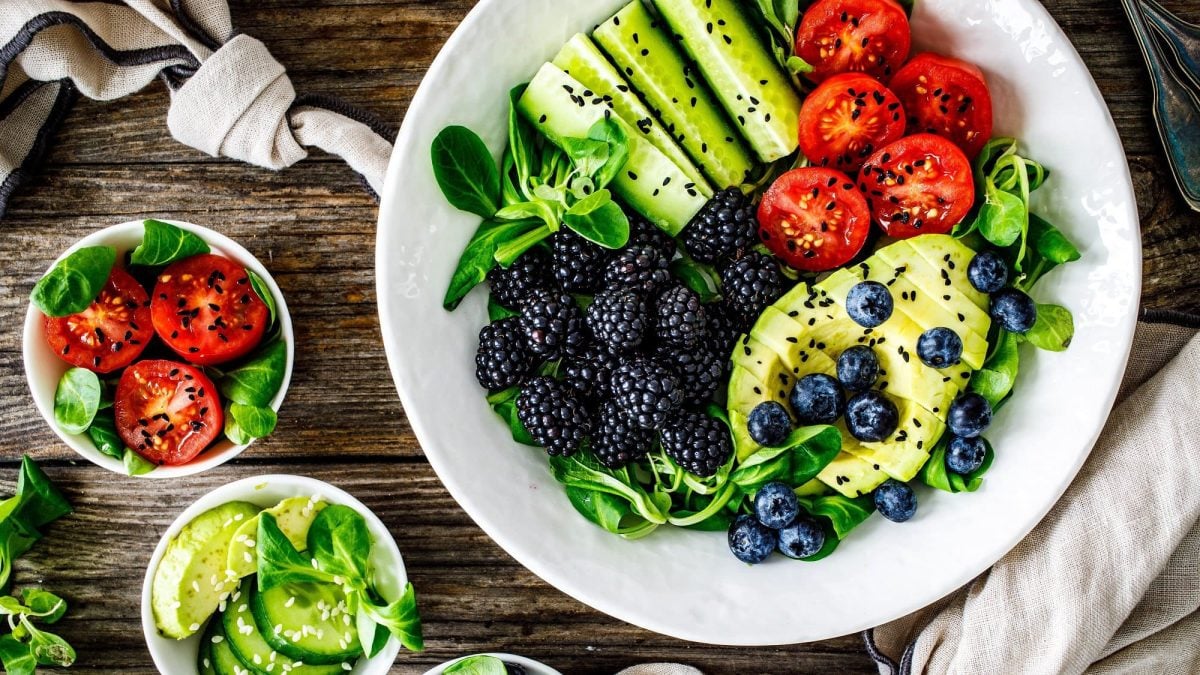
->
xmin=150 ymin=502 xmax=258 ymax=640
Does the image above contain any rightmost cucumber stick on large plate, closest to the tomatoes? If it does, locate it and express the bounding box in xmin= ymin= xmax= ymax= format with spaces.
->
xmin=655 ymin=0 xmax=800 ymax=162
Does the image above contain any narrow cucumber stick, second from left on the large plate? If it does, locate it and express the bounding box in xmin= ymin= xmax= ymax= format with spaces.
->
xmin=552 ymin=32 xmax=706 ymax=194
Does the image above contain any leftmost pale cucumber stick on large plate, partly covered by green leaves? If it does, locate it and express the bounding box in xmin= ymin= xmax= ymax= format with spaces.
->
xmin=517 ymin=64 xmax=712 ymax=235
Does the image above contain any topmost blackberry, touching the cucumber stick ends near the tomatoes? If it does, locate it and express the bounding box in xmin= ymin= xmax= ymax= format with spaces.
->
xmin=679 ymin=187 xmax=758 ymax=264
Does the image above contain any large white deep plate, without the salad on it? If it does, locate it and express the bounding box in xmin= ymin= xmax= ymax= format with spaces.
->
xmin=376 ymin=0 xmax=1141 ymax=645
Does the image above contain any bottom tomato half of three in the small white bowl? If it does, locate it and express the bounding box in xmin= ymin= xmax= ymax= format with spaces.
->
xmin=113 ymin=360 xmax=224 ymax=466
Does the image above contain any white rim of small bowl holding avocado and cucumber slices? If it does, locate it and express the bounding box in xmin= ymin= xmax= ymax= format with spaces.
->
xmin=140 ymin=473 xmax=408 ymax=675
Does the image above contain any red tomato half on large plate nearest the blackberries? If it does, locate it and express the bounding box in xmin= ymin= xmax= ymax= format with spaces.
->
xmin=758 ymin=167 xmax=871 ymax=271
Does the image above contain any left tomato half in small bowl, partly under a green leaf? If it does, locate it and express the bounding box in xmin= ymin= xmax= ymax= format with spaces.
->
xmin=46 ymin=267 xmax=154 ymax=372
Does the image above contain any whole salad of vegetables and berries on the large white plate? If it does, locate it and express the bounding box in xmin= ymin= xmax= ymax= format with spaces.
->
xmin=432 ymin=0 xmax=1080 ymax=563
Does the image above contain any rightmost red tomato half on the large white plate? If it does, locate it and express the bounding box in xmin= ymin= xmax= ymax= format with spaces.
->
xmin=892 ymin=53 xmax=991 ymax=159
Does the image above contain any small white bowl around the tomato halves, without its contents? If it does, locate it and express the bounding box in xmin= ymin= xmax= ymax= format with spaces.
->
xmin=23 ymin=220 xmax=295 ymax=478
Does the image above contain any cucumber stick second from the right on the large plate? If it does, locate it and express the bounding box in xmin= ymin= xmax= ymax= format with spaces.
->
xmin=595 ymin=0 xmax=755 ymax=187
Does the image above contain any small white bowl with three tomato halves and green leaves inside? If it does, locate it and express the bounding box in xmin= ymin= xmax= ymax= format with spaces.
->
xmin=24 ymin=220 xmax=295 ymax=478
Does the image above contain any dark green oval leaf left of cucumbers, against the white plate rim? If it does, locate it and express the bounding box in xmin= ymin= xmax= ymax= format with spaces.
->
xmin=432 ymin=126 xmax=500 ymax=217
